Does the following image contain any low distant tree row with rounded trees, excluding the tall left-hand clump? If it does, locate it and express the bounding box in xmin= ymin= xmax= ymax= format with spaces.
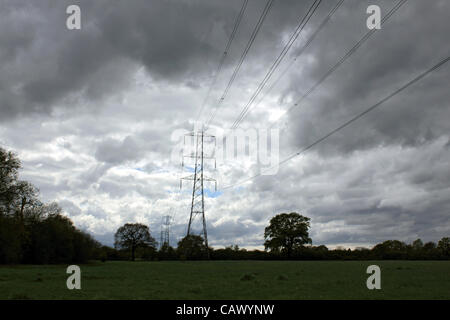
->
xmin=109 ymin=212 xmax=450 ymax=260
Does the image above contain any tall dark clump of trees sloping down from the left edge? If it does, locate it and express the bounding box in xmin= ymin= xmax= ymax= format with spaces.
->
xmin=0 ymin=148 xmax=101 ymax=264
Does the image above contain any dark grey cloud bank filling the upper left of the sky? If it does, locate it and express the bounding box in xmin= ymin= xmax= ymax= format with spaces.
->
xmin=0 ymin=0 xmax=330 ymax=119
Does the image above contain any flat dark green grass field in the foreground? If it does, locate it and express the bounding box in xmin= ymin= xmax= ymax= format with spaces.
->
xmin=0 ymin=261 xmax=450 ymax=299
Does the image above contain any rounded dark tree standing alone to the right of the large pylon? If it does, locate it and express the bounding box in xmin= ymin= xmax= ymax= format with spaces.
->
xmin=264 ymin=212 xmax=312 ymax=258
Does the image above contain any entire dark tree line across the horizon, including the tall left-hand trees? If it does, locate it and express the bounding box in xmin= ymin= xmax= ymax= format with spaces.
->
xmin=0 ymin=147 xmax=450 ymax=264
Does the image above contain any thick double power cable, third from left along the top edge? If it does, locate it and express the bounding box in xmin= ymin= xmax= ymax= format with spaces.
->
xmin=231 ymin=0 xmax=322 ymax=129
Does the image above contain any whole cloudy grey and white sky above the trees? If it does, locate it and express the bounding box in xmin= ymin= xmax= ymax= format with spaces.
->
xmin=0 ymin=0 xmax=450 ymax=248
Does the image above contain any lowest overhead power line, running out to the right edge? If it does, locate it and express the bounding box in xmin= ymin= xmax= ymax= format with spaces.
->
xmin=223 ymin=56 xmax=450 ymax=190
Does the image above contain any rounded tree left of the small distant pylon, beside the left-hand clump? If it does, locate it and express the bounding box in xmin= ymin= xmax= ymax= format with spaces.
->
xmin=114 ymin=223 xmax=156 ymax=261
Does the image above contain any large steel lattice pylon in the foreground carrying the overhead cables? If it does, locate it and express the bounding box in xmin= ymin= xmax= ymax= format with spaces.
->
xmin=180 ymin=129 xmax=217 ymax=257
